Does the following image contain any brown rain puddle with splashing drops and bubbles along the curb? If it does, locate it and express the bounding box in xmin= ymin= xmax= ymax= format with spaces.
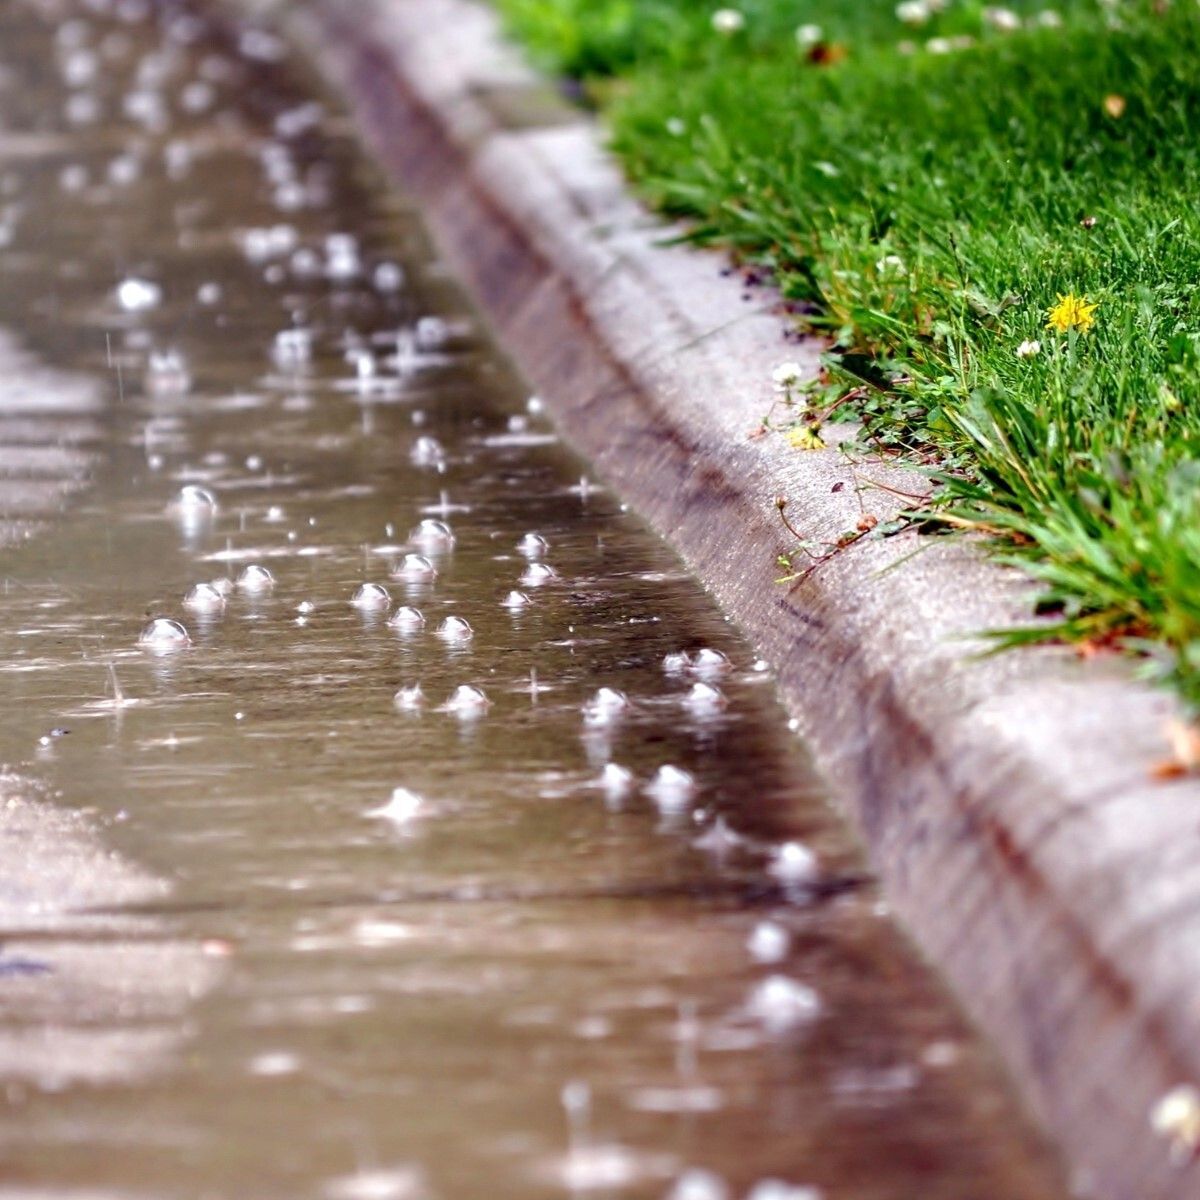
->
xmin=0 ymin=0 xmax=1063 ymax=1200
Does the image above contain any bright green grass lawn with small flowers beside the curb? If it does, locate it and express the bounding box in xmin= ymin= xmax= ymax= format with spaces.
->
xmin=497 ymin=0 xmax=1200 ymax=709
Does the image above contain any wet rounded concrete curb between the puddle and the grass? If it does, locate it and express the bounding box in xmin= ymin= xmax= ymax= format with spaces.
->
xmin=242 ymin=0 xmax=1200 ymax=1200
